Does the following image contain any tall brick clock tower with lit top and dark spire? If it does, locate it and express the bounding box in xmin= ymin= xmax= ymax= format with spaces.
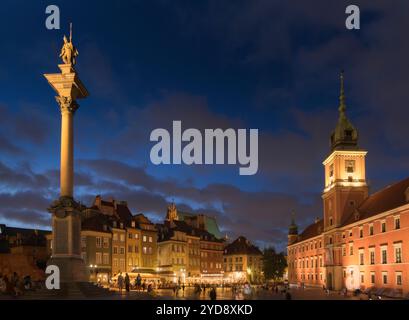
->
xmin=322 ymin=72 xmax=368 ymax=290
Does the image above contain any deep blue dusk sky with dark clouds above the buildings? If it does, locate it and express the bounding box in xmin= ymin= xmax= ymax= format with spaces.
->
xmin=0 ymin=0 xmax=409 ymax=249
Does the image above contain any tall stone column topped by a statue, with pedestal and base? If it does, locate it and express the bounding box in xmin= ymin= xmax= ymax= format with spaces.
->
xmin=44 ymin=27 xmax=88 ymax=283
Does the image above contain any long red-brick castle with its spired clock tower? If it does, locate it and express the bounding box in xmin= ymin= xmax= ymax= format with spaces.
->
xmin=287 ymin=75 xmax=409 ymax=297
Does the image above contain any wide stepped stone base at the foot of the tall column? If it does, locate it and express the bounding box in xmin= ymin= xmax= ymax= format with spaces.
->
xmin=47 ymin=257 xmax=89 ymax=283
